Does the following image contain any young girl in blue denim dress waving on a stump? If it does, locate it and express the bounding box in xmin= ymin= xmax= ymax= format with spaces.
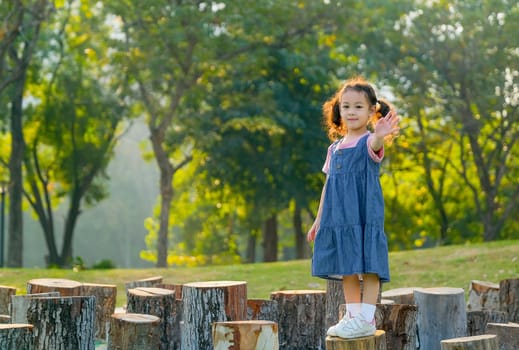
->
xmin=307 ymin=78 xmax=399 ymax=338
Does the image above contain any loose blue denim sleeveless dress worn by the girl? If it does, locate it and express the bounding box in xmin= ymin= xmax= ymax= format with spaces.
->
xmin=312 ymin=134 xmax=389 ymax=282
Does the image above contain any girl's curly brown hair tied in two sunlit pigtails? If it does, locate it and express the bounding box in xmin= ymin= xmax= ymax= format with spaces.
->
xmin=323 ymin=77 xmax=394 ymax=141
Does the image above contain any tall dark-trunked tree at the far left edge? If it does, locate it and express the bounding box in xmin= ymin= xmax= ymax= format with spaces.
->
xmin=0 ymin=0 xmax=52 ymax=267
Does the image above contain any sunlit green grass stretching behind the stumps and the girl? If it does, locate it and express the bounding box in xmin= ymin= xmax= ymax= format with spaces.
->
xmin=0 ymin=240 xmax=519 ymax=306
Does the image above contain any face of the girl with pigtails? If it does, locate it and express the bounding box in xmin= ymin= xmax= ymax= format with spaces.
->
xmin=340 ymin=89 xmax=375 ymax=135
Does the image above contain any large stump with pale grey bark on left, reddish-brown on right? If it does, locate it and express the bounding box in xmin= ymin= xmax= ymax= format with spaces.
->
xmin=181 ymin=281 xmax=247 ymax=350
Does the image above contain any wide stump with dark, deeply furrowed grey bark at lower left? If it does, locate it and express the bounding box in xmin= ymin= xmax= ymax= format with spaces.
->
xmin=27 ymin=296 xmax=96 ymax=350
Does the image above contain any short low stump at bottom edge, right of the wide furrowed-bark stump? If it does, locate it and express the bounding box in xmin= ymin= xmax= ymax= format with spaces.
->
xmin=107 ymin=313 xmax=160 ymax=350
